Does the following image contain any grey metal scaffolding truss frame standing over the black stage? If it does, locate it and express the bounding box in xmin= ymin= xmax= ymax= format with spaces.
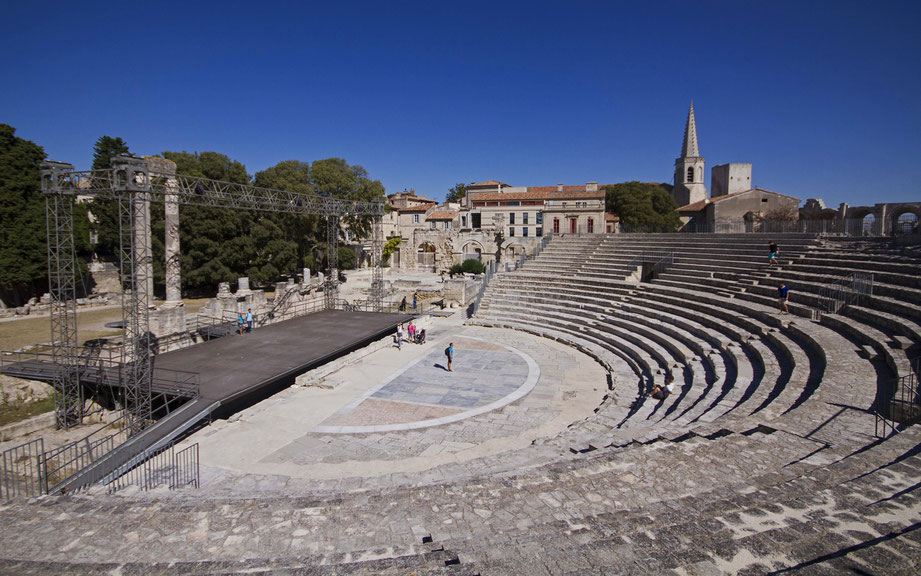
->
xmin=42 ymin=156 xmax=384 ymax=432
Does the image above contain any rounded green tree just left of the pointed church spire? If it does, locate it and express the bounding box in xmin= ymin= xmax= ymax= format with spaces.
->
xmin=604 ymin=182 xmax=681 ymax=232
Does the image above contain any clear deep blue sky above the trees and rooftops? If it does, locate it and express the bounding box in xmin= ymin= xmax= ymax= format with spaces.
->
xmin=0 ymin=0 xmax=921 ymax=207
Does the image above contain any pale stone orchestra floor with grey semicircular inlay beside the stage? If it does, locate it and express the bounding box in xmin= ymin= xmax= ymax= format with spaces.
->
xmin=186 ymin=326 xmax=607 ymax=494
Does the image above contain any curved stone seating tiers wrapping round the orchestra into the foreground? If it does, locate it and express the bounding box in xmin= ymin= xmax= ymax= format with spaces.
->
xmin=0 ymin=235 xmax=921 ymax=576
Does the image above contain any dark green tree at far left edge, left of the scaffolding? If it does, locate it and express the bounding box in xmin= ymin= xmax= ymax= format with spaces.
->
xmin=0 ymin=124 xmax=48 ymax=305
